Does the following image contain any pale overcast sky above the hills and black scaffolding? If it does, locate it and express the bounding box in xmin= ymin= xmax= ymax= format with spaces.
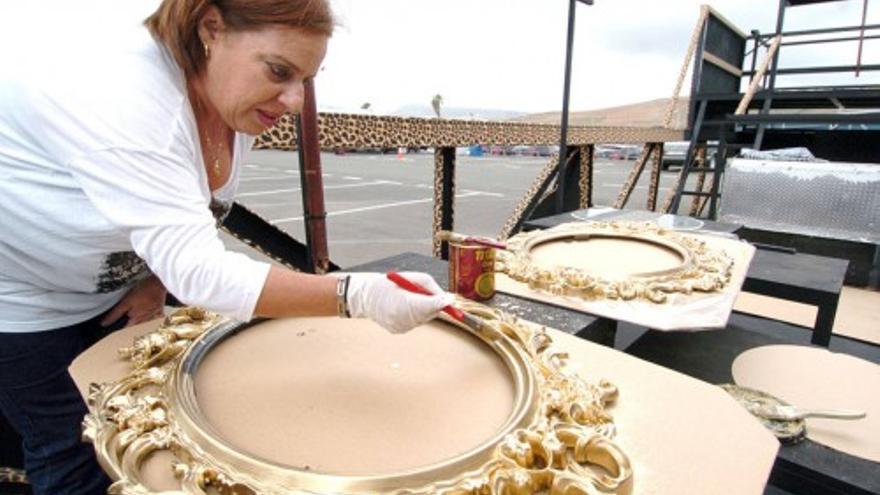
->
xmin=0 ymin=0 xmax=880 ymax=114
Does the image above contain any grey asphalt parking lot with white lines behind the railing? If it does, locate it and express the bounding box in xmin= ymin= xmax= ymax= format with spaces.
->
xmin=224 ymin=150 xmax=700 ymax=268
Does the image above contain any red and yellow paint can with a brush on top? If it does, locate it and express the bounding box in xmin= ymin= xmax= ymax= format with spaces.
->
xmin=449 ymin=242 xmax=495 ymax=301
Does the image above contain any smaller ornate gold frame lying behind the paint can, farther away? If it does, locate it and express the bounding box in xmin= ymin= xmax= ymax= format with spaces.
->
xmin=495 ymin=222 xmax=733 ymax=303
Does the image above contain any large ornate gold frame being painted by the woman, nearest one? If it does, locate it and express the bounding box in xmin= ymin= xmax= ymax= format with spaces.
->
xmin=83 ymin=300 xmax=632 ymax=495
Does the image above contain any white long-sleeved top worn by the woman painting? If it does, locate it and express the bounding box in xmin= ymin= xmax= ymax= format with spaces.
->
xmin=0 ymin=27 xmax=269 ymax=332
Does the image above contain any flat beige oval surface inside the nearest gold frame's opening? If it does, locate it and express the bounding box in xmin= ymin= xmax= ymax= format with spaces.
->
xmin=195 ymin=318 xmax=514 ymax=475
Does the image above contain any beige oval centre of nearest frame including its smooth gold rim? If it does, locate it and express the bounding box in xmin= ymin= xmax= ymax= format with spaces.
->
xmin=169 ymin=317 xmax=538 ymax=493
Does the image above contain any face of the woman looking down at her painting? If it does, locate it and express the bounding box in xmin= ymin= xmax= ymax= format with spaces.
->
xmin=201 ymin=18 xmax=327 ymax=135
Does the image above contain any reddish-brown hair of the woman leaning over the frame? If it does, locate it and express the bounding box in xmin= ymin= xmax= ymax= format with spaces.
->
xmin=144 ymin=0 xmax=334 ymax=77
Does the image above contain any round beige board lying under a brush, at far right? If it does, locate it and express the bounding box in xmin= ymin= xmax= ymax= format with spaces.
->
xmin=732 ymin=345 xmax=880 ymax=462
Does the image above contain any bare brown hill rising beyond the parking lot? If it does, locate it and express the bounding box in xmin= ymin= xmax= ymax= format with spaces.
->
xmin=510 ymin=97 xmax=688 ymax=129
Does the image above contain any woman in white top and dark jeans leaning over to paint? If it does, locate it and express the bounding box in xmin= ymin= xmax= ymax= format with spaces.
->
xmin=0 ymin=0 xmax=450 ymax=495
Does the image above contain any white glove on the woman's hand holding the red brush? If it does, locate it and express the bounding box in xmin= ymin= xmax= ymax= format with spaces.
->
xmin=345 ymin=272 xmax=455 ymax=333
